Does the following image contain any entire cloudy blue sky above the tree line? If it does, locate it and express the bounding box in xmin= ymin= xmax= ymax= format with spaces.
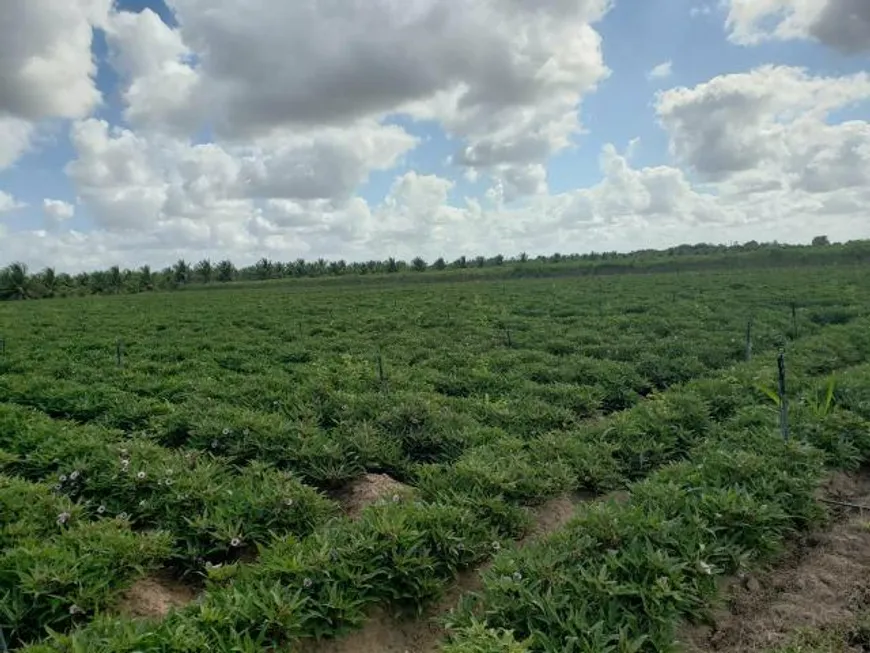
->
xmin=0 ymin=0 xmax=870 ymax=272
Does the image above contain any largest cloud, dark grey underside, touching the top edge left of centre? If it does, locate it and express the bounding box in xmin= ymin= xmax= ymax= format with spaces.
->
xmin=107 ymin=0 xmax=610 ymax=195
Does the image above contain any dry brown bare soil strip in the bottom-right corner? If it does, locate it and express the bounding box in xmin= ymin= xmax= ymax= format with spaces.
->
xmin=680 ymin=472 xmax=870 ymax=653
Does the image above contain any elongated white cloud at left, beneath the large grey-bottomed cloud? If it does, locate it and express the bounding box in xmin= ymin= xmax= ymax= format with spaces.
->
xmin=66 ymin=119 xmax=416 ymax=237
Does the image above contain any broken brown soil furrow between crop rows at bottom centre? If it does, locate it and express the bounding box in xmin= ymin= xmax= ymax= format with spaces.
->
xmin=298 ymin=495 xmax=591 ymax=653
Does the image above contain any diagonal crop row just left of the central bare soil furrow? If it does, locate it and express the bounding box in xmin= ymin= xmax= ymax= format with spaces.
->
xmin=18 ymin=314 xmax=870 ymax=652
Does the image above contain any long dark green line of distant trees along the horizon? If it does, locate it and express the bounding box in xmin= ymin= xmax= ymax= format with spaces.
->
xmin=0 ymin=236 xmax=870 ymax=301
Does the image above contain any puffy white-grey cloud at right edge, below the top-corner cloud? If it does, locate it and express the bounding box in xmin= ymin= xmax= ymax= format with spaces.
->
xmin=656 ymin=66 xmax=870 ymax=190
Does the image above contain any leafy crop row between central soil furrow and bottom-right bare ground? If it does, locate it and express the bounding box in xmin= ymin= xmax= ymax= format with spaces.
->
xmin=443 ymin=388 xmax=870 ymax=653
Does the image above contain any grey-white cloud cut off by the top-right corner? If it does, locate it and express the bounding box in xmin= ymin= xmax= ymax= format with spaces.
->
xmin=726 ymin=0 xmax=870 ymax=54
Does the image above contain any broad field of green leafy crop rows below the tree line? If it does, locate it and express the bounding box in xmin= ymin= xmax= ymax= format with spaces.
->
xmin=0 ymin=266 xmax=870 ymax=653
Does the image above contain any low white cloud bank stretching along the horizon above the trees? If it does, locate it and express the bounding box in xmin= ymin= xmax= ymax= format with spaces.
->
xmin=6 ymin=131 xmax=870 ymax=269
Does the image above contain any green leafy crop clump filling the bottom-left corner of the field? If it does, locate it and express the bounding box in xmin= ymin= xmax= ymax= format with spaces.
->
xmin=0 ymin=474 xmax=171 ymax=646
